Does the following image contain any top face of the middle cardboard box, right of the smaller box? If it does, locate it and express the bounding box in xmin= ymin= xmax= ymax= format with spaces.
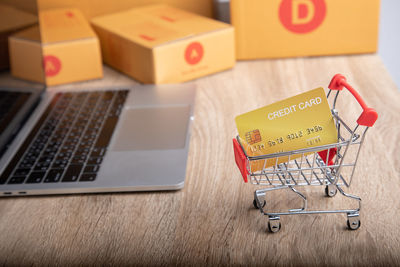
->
xmin=91 ymin=5 xmax=231 ymax=48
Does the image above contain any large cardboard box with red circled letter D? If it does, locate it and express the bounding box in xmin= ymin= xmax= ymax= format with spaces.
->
xmin=231 ymin=0 xmax=380 ymax=59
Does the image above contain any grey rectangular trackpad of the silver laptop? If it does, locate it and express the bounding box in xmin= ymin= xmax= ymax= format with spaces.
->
xmin=111 ymin=105 xmax=190 ymax=151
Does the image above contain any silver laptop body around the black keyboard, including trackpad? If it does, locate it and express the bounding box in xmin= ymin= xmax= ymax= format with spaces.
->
xmin=0 ymin=84 xmax=195 ymax=196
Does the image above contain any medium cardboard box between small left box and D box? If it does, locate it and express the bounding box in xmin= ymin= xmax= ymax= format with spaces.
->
xmin=91 ymin=5 xmax=235 ymax=84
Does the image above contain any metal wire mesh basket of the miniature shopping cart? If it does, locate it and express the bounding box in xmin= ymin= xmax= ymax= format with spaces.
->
xmin=237 ymin=110 xmax=368 ymax=187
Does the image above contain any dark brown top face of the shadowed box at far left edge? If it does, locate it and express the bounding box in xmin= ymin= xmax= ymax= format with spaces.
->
xmin=0 ymin=4 xmax=37 ymax=32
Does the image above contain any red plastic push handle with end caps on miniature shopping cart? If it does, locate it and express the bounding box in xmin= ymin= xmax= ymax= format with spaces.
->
xmin=328 ymin=74 xmax=378 ymax=127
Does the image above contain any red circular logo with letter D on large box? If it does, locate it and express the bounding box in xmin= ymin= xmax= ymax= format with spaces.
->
xmin=279 ymin=0 xmax=326 ymax=33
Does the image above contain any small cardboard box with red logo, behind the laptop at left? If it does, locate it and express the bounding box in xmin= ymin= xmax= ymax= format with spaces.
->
xmin=9 ymin=9 xmax=103 ymax=86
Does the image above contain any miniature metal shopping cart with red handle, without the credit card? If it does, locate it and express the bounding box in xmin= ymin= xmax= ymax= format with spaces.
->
xmin=233 ymin=74 xmax=378 ymax=232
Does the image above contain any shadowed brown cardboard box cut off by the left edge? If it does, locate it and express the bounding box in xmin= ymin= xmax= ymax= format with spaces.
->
xmin=0 ymin=4 xmax=37 ymax=70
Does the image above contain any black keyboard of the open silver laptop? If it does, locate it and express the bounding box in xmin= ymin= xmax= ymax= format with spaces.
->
xmin=0 ymin=90 xmax=128 ymax=184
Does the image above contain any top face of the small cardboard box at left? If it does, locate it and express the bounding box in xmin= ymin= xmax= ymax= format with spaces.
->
xmin=39 ymin=8 xmax=96 ymax=44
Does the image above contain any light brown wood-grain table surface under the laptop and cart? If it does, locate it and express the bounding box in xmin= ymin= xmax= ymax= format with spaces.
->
xmin=0 ymin=55 xmax=400 ymax=265
